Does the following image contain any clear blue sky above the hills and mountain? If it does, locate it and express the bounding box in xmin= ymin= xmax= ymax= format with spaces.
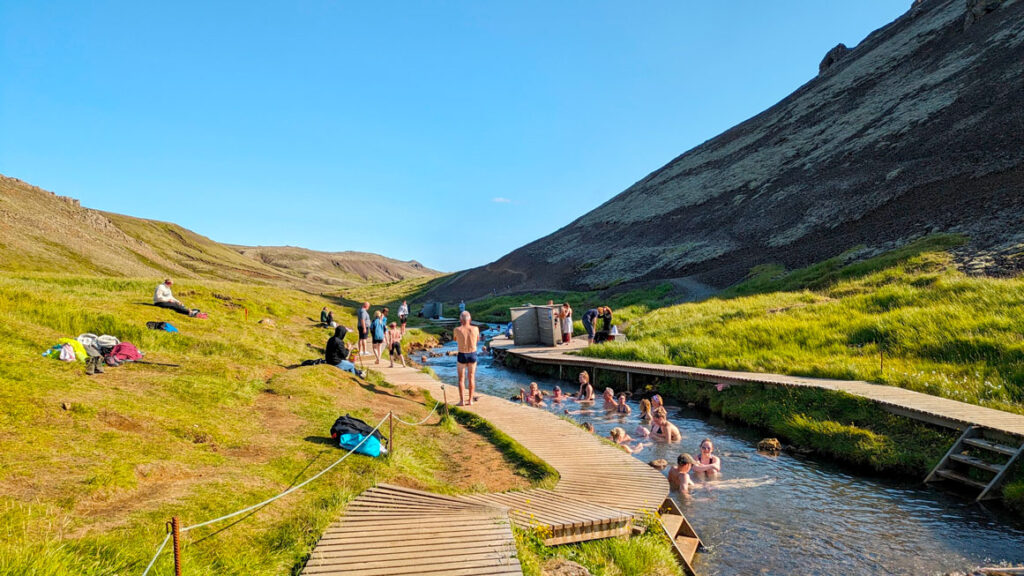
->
xmin=0 ymin=0 xmax=910 ymax=271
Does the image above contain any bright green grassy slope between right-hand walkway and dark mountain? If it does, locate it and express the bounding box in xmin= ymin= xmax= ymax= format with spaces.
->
xmin=586 ymin=238 xmax=1024 ymax=413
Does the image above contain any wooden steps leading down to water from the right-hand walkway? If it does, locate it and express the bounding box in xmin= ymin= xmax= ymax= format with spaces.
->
xmin=925 ymin=426 xmax=1024 ymax=501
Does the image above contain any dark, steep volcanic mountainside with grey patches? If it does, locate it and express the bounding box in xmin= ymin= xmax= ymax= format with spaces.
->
xmin=437 ymin=0 xmax=1024 ymax=297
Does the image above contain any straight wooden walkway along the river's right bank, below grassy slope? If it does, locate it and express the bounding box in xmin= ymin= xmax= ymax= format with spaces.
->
xmin=490 ymin=338 xmax=1024 ymax=437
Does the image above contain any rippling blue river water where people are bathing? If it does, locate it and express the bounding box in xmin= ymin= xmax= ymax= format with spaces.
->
xmin=415 ymin=336 xmax=1024 ymax=575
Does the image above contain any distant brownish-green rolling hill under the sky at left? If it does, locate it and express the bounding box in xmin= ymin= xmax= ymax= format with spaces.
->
xmin=0 ymin=171 xmax=438 ymax=290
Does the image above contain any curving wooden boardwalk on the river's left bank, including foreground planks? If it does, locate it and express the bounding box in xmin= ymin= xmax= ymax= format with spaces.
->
xmin=302 ymin=367 xmax=669 ymax=576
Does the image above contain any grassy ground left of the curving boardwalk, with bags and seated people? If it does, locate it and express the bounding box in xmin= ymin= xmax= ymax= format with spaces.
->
xmin=0 ymin=275 xmax=501 ymax=575
